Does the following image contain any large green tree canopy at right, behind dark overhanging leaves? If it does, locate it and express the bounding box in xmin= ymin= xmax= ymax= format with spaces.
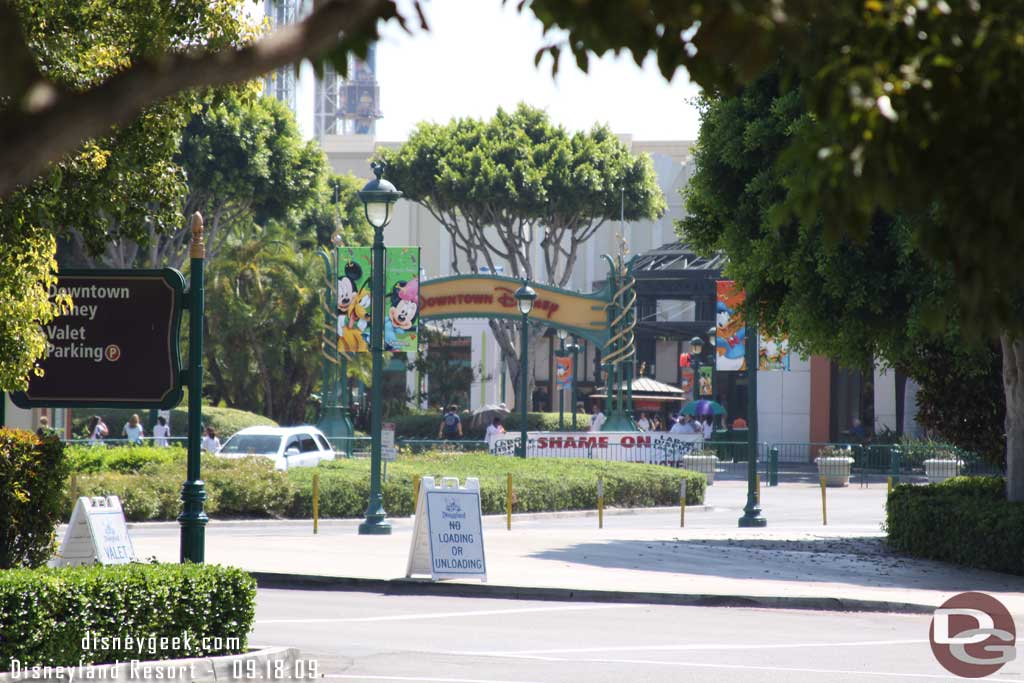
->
xmin=680 ymin=73 xmax=1004 ymax=460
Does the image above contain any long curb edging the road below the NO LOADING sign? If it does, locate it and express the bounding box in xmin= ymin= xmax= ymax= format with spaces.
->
xmin=250 ymin=571 xmax=935 ymax=614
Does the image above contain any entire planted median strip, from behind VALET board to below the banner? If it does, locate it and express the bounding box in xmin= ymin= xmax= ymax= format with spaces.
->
xmin=66 ymin=446 xmax=707 ymax=521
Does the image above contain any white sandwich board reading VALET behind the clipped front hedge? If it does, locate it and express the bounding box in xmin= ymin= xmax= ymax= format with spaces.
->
xmin=49 ymin=496 xmax=135 ymax=567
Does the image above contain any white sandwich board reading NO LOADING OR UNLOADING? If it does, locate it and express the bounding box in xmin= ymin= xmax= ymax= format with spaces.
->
xmin=406 ymin=477 xmax=487 ymax=582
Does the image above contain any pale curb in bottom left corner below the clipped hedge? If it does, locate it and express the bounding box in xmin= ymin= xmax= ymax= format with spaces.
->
xmin=0 ymin=647 xmax=304 ymax=683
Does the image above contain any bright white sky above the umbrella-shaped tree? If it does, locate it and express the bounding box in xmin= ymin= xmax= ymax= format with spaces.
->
xmin=377 ymin=0 xmax=699 ymax=141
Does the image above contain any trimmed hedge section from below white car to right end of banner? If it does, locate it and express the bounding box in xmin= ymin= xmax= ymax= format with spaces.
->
xmin=288 ymin=454 xmax=707 ymax=517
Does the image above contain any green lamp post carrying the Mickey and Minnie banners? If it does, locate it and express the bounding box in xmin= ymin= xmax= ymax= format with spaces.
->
xmin=359 ymin=162 xmax=401 ymax=535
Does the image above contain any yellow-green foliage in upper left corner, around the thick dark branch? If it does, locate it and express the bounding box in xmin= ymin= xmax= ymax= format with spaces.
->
xmin=0 ymin=0 xmax=249 ymax=390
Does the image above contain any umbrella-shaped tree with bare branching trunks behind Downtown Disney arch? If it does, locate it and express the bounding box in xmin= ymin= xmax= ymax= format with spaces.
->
xmin=381 ymin=104 xmax=666 ymax=397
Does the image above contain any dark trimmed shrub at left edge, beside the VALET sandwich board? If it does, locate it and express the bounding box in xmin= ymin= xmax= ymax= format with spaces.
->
xmin=0 ymin=430 xmax=68 ymax=569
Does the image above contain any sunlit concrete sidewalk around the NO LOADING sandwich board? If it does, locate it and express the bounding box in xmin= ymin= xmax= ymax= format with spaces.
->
xmin=131 ymin=481 xmax=1024 ymax=615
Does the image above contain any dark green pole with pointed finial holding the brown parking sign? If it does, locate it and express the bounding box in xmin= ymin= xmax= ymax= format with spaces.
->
xmin=178 ymin=211 xmax=210 ymax=563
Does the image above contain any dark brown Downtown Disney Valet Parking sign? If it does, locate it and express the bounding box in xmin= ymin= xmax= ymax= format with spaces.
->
xmin=11 ymin=268 xmax=185 ymax=408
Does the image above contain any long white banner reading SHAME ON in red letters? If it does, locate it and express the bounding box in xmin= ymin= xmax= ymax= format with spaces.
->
xmin=490 ymin=432 xmax=703 ymax=465
